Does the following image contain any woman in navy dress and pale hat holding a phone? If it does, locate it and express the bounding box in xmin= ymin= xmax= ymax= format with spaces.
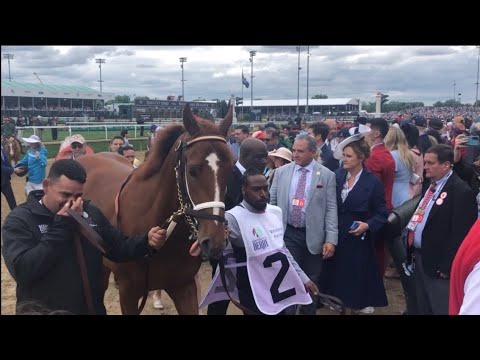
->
xmin=323 ymin=134 xmax=388 ymax=313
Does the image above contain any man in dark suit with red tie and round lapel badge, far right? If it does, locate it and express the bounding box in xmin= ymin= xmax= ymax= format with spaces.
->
xmin=407 ymin=144 xmax=477 ymax=315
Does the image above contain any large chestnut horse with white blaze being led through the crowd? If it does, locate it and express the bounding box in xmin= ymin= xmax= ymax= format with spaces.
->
xmin=78 ymin=105 xmax=233 ymax=314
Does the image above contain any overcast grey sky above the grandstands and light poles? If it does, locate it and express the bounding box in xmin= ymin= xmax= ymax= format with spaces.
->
xmin=2 ymin=45 xmax=478 ymax=105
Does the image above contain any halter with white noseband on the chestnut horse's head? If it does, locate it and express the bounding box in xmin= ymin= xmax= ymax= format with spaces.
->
xmin=175 ymin=135 xmax=227 ymax=238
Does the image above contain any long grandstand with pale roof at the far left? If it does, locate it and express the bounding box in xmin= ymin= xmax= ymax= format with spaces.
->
xmin=1 ymin=80 xmax=114 ymax=117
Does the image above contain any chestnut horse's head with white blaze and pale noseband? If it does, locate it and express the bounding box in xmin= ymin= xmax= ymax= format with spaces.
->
xmin=177 ymin=104 xmax=233 ymax=259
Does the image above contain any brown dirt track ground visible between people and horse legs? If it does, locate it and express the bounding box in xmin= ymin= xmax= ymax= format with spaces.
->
xmin=1 ymin=155 xmax=405 ymax=315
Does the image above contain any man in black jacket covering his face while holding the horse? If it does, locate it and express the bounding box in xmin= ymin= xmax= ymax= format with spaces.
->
xmin=2 ymin=159 xmax=166 ymax=315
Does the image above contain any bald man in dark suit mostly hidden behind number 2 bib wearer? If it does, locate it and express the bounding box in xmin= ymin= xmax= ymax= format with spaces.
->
xmin=207 ymin=138 xmax=268 ymax=315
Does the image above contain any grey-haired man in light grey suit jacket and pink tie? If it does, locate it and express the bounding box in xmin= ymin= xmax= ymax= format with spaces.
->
xmin=270 ymin=134 xmax=338 ymax=315
